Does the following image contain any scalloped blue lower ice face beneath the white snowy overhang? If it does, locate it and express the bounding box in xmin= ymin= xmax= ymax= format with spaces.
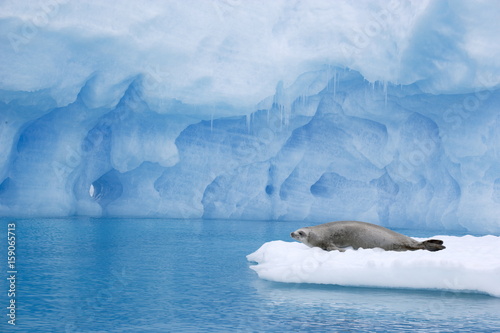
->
xmin=0 ymin=68 xmax=500 ymax=231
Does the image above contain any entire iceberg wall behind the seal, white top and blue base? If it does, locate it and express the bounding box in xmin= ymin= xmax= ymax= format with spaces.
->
xmin=0 ymin=0 xmax=500 ymax=233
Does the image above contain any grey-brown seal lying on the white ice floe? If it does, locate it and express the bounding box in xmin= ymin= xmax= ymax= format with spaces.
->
xmin=291 ymin=221 xmax=446 ymax=252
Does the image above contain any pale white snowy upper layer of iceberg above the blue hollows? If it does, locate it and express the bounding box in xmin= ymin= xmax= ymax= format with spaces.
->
xmin=0 ymin=0 xmax=500 ymax=107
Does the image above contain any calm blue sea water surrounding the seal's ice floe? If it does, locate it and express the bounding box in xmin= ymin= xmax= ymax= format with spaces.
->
xmin=0 ymin=218 xmax=500 ymax=332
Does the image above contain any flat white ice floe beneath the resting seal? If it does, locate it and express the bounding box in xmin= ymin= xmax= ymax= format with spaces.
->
xmin=247 ymin=236 xmax=500 ymax=297
